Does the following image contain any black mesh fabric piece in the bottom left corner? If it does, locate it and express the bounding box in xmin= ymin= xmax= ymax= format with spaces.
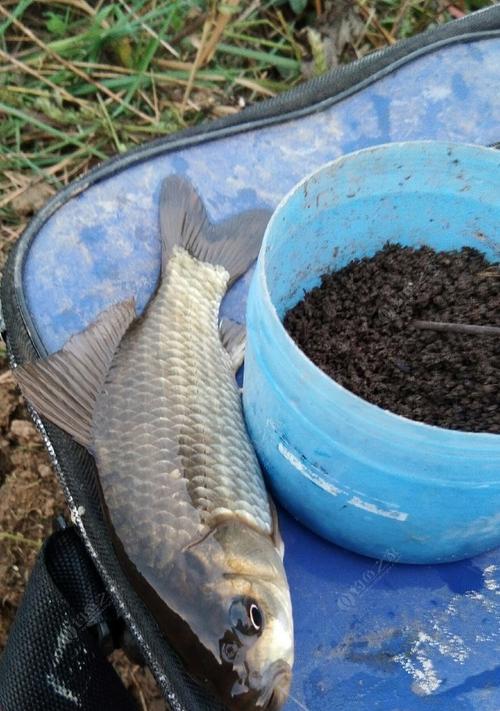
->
xmin=0 ymin=527 xmax=138 ymax=711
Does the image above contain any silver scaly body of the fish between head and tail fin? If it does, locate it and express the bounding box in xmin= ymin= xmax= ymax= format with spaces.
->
xmin=93 ymin=248 xmax=272 ymax=570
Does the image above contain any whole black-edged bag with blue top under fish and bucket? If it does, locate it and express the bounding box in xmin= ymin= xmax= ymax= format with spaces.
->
xmin=0 ymin=6 xmax=500 ymax=711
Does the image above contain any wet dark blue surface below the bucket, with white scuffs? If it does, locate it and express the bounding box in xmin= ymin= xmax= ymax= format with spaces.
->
xmin=280 ymin=513 xmax=500 ymax=711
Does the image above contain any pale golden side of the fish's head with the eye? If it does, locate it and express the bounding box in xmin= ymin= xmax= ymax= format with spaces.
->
xmin=201 ymin=522 xmax=293 ymax=711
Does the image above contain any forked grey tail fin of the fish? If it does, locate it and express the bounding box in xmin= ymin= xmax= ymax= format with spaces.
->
xmin=160 ymin=175 xmax=271 ymax=285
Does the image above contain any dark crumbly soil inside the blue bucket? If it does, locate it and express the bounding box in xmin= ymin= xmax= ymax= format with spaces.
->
xmin=285 ymin=244 xmax=500 ymax=433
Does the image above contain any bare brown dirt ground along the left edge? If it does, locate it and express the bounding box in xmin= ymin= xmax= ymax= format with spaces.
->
xmin=0 ymin=348 xmax=166 ymax=711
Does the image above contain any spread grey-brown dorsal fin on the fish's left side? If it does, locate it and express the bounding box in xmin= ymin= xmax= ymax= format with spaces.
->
xmin=14 ymin=299 xmax=135 ymax=448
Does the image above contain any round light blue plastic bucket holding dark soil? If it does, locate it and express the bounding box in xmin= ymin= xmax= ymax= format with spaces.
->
xmin=243 ymin=142 xmax=500 ymax=563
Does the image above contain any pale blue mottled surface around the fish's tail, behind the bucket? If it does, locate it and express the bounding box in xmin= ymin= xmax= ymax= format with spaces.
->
xmin=25 ymin=39 xmax=500 ymax=350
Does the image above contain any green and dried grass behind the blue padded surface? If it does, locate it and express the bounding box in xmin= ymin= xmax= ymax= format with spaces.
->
xmin=0 ymin=0 xmax=492 ymax=265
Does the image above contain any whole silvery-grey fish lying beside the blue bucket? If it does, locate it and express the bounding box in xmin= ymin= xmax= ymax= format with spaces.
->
xmin=14 ymin=175 xmax=294 ymax=711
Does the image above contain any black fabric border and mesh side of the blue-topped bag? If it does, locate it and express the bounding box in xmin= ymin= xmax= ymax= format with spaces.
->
xmin=0 ymin=6 xmax=500 ymax=711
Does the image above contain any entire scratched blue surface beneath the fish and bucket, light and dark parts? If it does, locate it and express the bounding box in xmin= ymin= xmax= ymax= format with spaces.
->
xmin=25 ymin=39 xmax=500 ymax=711
